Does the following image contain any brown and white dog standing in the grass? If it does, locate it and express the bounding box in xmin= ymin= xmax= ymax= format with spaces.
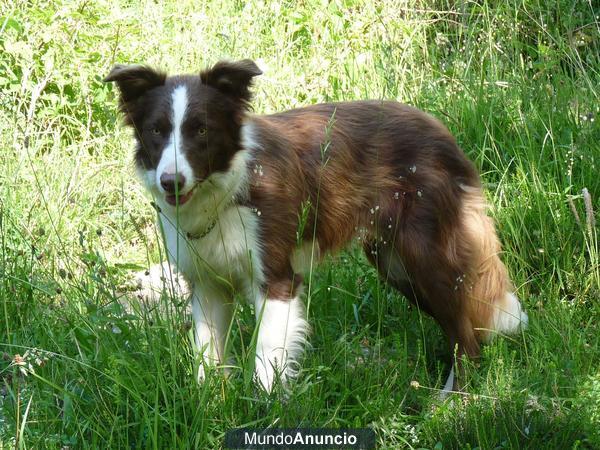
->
xmin=106 ymin=60 xmax=527 ymax=391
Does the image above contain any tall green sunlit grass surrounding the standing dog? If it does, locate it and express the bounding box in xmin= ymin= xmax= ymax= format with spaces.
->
xmin=0 ymin=0 xmax=600 ymax=449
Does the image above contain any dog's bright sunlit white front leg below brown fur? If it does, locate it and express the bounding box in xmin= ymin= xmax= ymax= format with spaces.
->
xmin=255 ymin=297 xmax=308 ymax=392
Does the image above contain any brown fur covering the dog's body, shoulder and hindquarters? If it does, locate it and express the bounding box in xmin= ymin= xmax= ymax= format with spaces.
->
xmin=248 ymin=102 xmax=510 ymax=374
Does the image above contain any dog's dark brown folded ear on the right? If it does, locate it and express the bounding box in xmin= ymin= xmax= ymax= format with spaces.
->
xmin=200 ymin=59 xmax=262 ymax=103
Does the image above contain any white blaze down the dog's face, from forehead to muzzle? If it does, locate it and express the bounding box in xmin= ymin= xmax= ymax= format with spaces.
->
xmin=156 ymin=86 xmax=194 ymax=194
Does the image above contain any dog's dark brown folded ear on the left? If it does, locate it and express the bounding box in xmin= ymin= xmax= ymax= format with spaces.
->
xmin=104 ymin=64 xmax=166 ymax=105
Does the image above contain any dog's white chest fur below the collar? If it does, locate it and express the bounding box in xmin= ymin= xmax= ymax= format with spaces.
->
xmin=163 ymin=206 xmax=262 ymax=288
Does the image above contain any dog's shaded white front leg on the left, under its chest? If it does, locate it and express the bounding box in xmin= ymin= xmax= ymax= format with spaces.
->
xmin=192 ymin=287 xmax=232 ymax=381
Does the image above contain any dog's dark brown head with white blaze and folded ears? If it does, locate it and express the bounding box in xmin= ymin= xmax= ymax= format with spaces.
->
xmin=105 ymin=60 xmax=262 ymax=207
